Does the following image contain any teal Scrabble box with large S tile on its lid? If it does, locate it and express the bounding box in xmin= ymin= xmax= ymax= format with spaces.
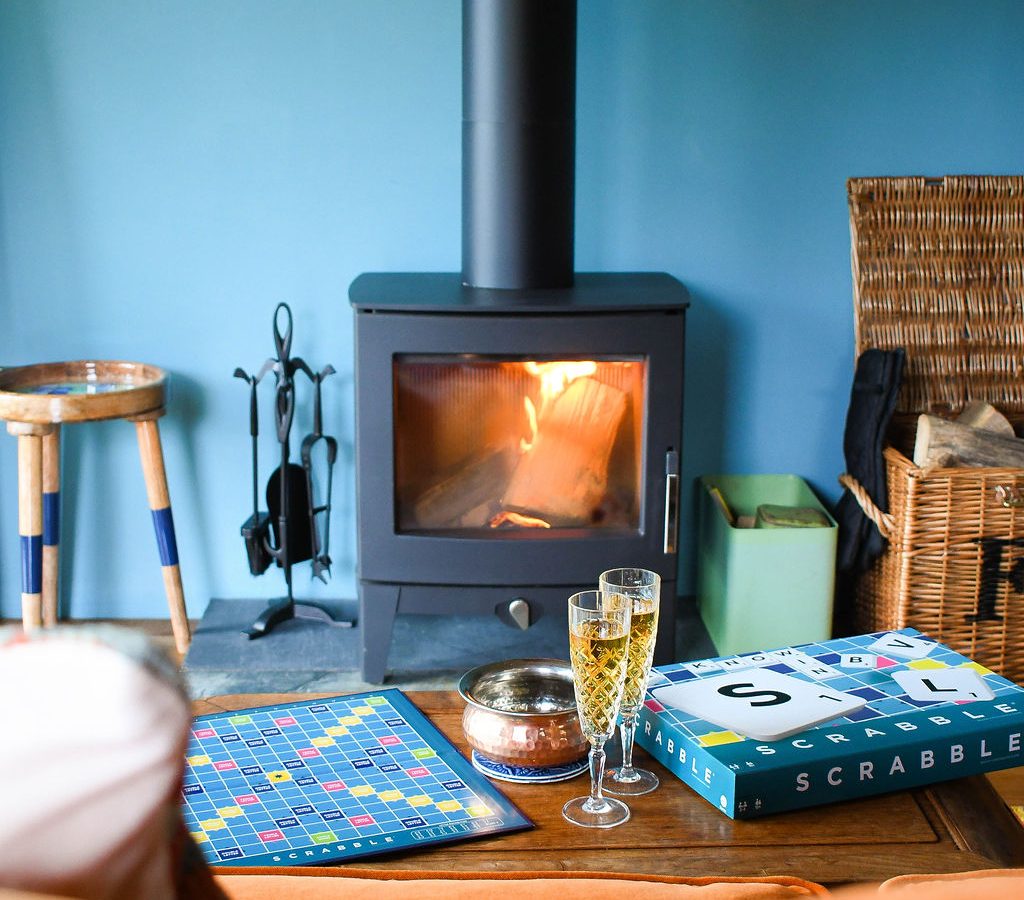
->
xmin=636 ymin=629 xmax=1024 ymax=818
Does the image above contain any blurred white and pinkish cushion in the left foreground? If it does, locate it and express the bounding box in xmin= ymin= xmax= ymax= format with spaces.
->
xmin=0 ymin=627 xmax=219 ymax=900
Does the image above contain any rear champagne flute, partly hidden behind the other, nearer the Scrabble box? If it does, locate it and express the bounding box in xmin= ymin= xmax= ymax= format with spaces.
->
xmin=599 ymin=568 xmax=662 ymax=797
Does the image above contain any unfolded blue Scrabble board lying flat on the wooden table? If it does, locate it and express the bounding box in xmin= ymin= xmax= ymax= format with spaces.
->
xmin=182 ymin=688 xmax=532 ymax=865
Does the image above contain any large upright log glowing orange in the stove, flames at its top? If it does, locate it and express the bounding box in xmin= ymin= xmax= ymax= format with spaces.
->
xmin=503 ymin=378 xmax=628 ymax=524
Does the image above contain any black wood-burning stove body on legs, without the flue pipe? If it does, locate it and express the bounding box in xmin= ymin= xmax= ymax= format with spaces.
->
xmin=350 ymin=273 xmax=687 ymax=682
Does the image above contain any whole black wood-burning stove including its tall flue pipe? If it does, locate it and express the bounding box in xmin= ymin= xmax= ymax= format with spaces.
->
xmin=349 ymin=0 xmax=689 ymax=682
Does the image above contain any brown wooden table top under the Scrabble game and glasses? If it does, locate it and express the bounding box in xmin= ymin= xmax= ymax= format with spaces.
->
xmin=194 ymin=691 xmax=1024 ymax=884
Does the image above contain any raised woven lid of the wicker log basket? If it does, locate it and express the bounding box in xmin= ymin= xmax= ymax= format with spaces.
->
xmin=847 ymin=175 xmax=1024 ymax=416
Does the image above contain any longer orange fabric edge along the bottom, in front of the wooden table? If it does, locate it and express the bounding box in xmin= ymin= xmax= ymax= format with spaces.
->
xmin=215 ymin=867 xmax=828 ymax=900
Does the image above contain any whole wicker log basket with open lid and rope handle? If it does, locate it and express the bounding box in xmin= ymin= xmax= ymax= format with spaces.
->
xmin=841 ymin=176 xmax=1024 ymax=681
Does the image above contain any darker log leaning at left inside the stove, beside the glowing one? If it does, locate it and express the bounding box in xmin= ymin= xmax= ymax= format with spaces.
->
xmin=413 ymin=446 xmax=516 ymax=528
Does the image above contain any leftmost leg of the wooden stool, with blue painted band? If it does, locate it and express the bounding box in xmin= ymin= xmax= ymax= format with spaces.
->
xmin=7 ymin=422 xmax=50 ymax=631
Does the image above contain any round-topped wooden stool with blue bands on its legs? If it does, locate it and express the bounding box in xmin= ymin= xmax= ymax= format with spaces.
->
xmin=0 ymin=360 xmax=189 ymax=653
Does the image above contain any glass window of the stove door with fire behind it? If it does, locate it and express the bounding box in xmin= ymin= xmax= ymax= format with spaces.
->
xmin=392 ymin=354 xmax=647 ymax=539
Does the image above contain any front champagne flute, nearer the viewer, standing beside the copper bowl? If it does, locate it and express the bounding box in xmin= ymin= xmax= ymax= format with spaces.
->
xmin=562 ymin=591 xmax=633 ymax=828
